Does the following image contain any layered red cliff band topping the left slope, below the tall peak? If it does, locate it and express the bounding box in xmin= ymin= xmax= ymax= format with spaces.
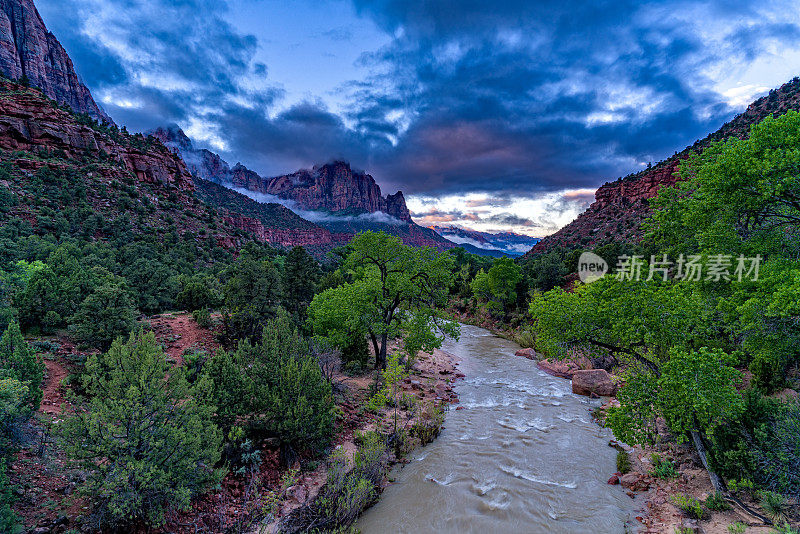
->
xmin=0 ymin=81 xmax=194 ymax=191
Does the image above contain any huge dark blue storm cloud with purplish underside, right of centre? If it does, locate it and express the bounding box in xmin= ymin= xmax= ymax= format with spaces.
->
xmin=346 ymin=0 xmax=798 ymax=194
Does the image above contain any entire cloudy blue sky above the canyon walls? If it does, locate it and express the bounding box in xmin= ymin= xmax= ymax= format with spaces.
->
xmin=36 ymin=0 xmax=800 ymax=236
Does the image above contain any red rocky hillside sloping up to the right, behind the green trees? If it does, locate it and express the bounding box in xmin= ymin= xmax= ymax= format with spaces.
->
xmin=526 ymin=78 xmax=800 ymax=257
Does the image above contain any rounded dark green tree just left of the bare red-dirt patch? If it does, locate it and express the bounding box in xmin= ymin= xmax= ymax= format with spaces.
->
xmin=70 ymin=284 xmax=136 ymax=350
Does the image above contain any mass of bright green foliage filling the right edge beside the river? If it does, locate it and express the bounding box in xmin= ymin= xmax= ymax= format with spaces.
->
xmin=530 ymin=112 xmax=800 ymax=506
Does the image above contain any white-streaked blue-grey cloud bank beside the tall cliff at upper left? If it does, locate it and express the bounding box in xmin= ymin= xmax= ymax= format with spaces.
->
xmin=47 ymin=0 xmax=281 ymax=133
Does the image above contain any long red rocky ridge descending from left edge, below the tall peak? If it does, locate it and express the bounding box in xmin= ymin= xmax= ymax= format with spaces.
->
xmin=0 ymin=80 xmax=341 ymax=252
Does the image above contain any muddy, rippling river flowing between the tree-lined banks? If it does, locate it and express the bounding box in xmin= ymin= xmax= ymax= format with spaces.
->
xmin=356 ymin=326 xmax=635 ymax=534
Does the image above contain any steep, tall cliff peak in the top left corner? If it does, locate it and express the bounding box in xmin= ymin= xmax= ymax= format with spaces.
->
xmin=0 ymin=0 xmax=113 ymax=123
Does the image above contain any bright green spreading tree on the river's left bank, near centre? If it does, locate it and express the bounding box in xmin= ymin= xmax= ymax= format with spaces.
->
xmin=308 ymin=232 xmax=458 ymax=369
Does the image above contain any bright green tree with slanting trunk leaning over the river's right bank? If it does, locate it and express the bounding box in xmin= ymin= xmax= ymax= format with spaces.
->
xmin=530 ymin=278 xmax=741 ymax=490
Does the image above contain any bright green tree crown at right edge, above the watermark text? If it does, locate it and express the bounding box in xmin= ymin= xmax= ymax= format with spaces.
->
xmin=645 ymin=110 xmax=800 ymax=256
